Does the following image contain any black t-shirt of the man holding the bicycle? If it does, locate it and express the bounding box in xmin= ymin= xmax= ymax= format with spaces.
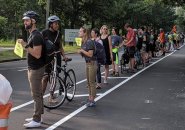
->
xmin=42 ymin=29 xmax=62 ymax=51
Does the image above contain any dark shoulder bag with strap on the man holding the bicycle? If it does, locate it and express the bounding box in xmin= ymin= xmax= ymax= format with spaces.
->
xmin=42 ymin=31 xmax=59 ymax=65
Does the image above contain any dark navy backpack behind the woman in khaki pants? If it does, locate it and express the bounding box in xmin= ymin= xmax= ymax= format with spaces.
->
xmin=93 ymin=40 xmax=106 ymax=65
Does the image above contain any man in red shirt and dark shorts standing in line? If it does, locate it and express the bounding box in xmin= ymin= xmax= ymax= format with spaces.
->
xmin=124 ymin=23 xmax=136 ymax=72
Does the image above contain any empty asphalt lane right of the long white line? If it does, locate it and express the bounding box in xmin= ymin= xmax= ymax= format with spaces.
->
xmin=57 ymin=48 xmax=185 ymax=130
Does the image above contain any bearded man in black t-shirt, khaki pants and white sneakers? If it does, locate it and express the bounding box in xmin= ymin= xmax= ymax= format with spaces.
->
xmin=18 ymin=11 xmax=45 ymax=128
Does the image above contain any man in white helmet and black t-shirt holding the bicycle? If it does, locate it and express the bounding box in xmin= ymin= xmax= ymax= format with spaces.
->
xmin=42 ymin=15 xmax=68 ymax=95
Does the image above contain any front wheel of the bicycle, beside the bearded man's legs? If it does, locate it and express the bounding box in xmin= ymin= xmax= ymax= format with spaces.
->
xmin=43 ymin=73 xmax=66 ymax=109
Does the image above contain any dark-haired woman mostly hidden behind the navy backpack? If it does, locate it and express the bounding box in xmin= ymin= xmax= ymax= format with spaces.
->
xmin=91 ymin=28 xmax=103 ymax=89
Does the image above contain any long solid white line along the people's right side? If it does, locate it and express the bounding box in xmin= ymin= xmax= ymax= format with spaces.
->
xmin=45 ymin=48 xmax=179 ymax=130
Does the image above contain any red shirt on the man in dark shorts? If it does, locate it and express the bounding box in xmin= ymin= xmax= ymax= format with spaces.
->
xmin=126 ymin=28 xmax=136 ymax=47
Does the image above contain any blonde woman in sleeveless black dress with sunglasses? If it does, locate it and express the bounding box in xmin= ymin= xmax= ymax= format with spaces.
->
xmin=100 ymin=25 xmax=113 ymax=84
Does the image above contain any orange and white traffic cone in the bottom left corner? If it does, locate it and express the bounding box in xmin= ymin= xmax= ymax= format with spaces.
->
xmin=0 ymin=102 xmax=12 ymax=130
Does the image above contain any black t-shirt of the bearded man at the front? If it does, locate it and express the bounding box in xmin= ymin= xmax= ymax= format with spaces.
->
xmin=27 ymin=30 xmax=44 ymax=70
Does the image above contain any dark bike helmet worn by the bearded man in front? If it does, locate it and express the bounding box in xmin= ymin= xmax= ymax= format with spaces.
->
xmin=22 ymin=11 xmax=39 ymax=22
